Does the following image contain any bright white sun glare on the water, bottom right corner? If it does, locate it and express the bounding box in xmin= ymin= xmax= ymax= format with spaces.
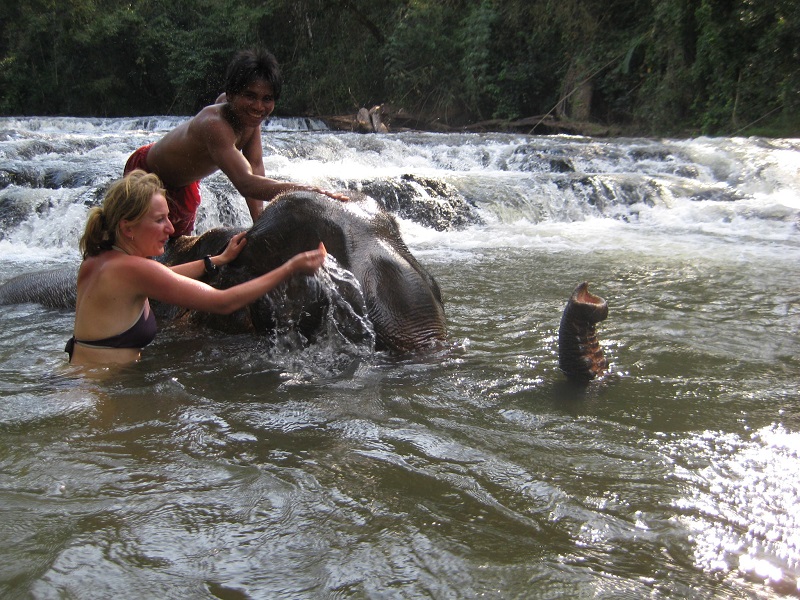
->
xmin=679 ymin=425 xmax=800 ymax=594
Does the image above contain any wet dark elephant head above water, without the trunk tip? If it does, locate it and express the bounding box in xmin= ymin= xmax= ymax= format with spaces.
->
xmin=165 ymin=192 xmax=447 ymax=353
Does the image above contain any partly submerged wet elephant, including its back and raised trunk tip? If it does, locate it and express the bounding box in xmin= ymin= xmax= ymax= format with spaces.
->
xmin=0 ymin=191 xmax=608 ymax=383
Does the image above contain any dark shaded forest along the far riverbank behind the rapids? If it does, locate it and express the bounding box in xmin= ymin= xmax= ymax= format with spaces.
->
xmin=0 ymin=0 xmax=800 ymax=137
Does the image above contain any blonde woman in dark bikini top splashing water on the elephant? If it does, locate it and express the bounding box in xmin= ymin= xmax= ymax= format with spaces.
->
xmin=65 ymin=170 xmax=326 ymax=365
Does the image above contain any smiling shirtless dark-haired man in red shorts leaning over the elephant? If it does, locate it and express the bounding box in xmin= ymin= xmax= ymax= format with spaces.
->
xmin=124 ymin=49 xmax=347 ymax=237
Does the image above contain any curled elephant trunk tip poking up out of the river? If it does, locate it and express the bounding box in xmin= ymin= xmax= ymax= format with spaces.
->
xmin=558 ymin=282 xmax=608 ymax=383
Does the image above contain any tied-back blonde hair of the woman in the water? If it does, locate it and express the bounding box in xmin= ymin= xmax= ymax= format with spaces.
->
xmin=79 ymin=169 xmax=166 ymax=258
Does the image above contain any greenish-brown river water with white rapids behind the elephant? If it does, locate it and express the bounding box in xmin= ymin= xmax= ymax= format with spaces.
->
xmin=0 ymin=117 xmax=800 ymax=599
